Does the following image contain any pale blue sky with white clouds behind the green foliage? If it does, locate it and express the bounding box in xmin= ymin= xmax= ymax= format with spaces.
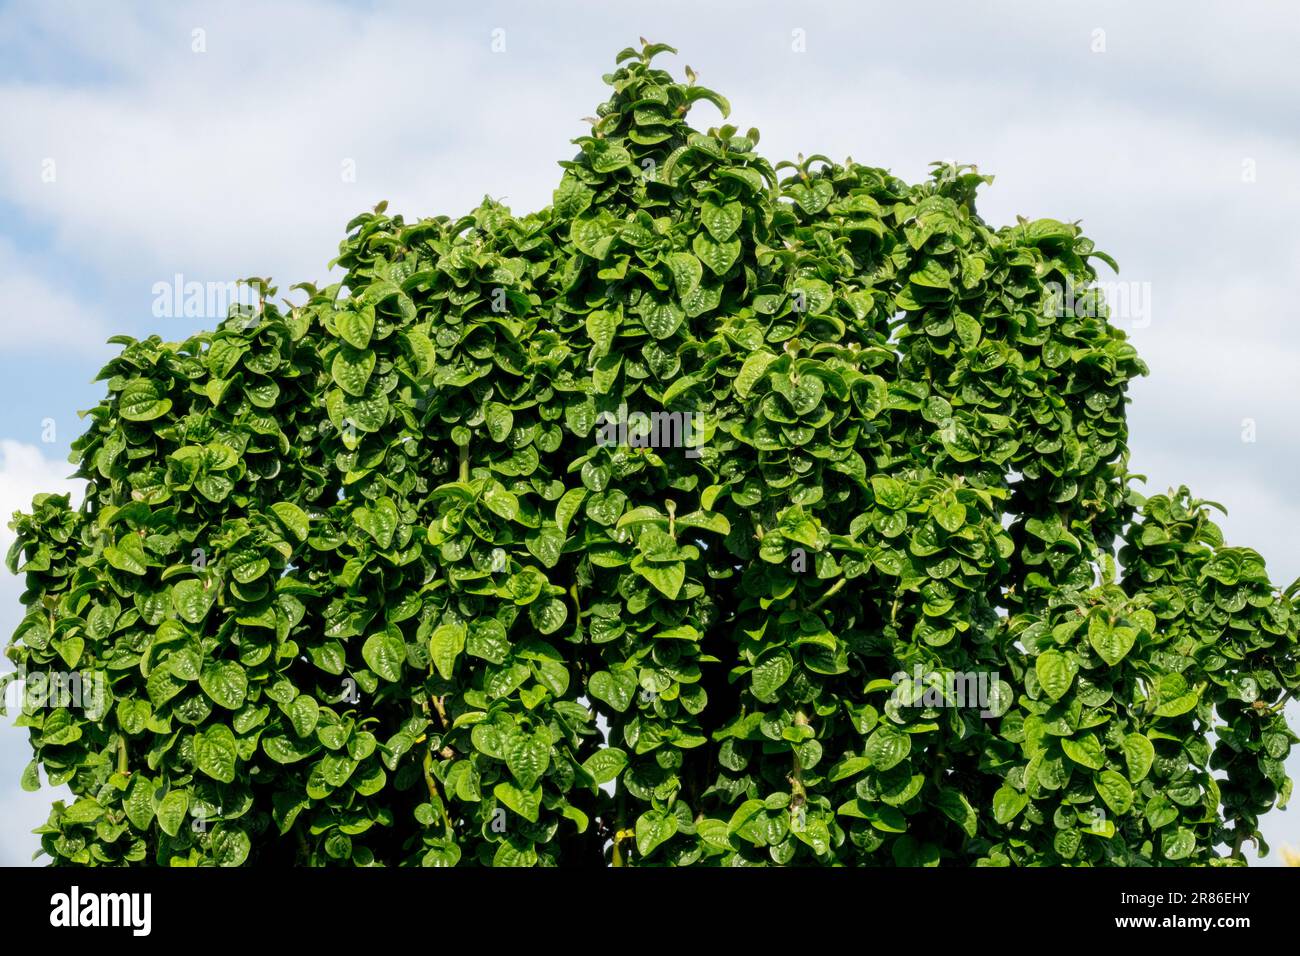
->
xmin=0 ymin=0 xmax=1300 ymax=864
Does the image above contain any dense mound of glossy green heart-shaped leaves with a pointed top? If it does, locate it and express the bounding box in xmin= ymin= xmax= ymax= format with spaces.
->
xmin=9 ymin=46 xmax=1300 ymax=865
